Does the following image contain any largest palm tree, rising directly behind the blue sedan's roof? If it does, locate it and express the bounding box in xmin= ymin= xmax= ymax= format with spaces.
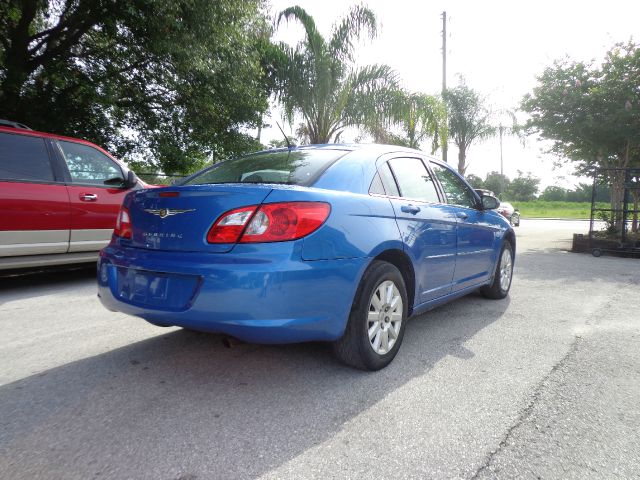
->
xmin=276 ymin=6 xmax=396 ymax=143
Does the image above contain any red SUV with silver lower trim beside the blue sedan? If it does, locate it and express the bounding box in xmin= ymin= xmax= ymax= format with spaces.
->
xmin=0 ymin=120 xmax=146 ymax=270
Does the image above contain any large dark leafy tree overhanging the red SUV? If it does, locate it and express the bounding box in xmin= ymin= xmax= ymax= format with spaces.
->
xmin=0 ymin=0 xmax=278 ymax=173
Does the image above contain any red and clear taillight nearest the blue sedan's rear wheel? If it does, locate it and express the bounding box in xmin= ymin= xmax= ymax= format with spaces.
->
xmin=207 ymin=202 xmax=331 ymax=243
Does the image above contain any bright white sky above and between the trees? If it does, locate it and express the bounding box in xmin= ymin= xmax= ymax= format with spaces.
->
xmin=262 ymin=0 xmax=640 ymax=188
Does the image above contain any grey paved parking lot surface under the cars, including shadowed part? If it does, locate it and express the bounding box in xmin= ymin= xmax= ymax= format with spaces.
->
xmin=0 ymin=219 xmax=640 ymax=480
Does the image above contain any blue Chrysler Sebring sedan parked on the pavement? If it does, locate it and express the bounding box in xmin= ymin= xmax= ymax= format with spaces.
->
xmin=98 ymin=145 xmax=515 ymax=370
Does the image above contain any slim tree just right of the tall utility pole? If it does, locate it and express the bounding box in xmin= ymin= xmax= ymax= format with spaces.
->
xmin=444 ymin=84 xmax=496 ymax=175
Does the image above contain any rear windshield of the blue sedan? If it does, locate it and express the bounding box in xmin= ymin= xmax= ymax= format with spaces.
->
xmin=183 ymin=150 xmax=347 ymax=186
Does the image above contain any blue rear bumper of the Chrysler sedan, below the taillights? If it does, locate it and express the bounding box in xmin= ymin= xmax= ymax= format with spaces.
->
xmin=98 ymin=244 xmax=368 ymax=343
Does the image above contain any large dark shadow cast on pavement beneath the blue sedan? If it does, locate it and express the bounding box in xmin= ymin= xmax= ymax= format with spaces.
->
xmin=0 ymin=288 xmax=509 ymax=479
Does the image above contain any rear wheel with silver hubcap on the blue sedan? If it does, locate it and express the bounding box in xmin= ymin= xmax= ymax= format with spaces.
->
xmin=333 ymin=260 xmax=409 ymax=371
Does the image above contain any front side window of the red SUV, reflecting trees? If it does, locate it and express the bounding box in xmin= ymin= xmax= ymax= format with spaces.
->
xmin=58 ymin=140 xmax=124 ymax=186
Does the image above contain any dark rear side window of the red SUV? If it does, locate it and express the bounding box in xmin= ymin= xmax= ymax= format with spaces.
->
xmin=0 ymin=133 xmax=54 ymax=182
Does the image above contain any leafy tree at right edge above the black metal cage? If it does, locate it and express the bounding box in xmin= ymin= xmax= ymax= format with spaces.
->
xmin=522 ymin=42 xmax=640 ymax=227
